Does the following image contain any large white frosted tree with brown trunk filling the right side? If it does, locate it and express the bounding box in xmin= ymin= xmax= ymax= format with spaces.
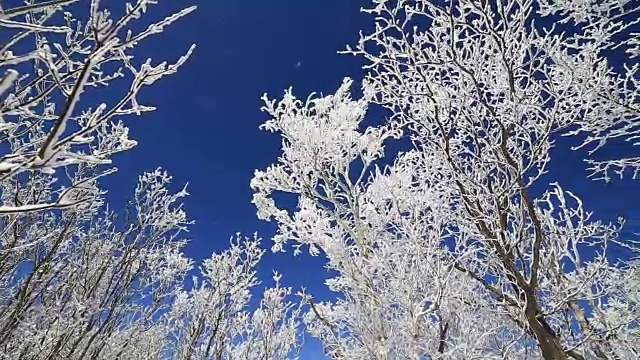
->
xmin=251 ymin=0 xmax=640 ymax=360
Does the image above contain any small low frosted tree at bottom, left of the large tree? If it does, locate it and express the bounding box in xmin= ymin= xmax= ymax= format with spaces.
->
xmin=168 ymin=235 xmax=300 ymax=360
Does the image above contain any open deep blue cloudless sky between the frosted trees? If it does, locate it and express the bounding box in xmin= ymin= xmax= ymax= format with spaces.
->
xmin=103 ymin=0 xmax=640 ymax=358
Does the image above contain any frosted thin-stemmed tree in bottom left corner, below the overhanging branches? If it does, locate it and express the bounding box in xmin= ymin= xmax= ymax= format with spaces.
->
xmin=0 ymin=170 xmax=191 ymax=359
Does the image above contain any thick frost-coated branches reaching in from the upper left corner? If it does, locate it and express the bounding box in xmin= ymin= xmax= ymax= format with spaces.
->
xmin=0 ymin=0 xmax=195 ymax=213
